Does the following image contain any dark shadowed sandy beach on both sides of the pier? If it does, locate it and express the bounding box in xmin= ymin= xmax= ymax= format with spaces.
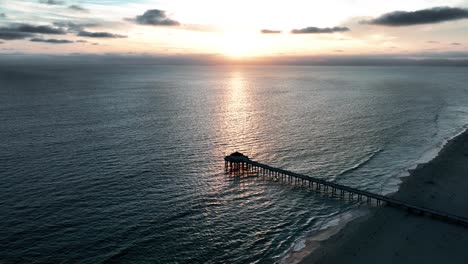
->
xmin=301 ymin=127 xmax=468 ymax=263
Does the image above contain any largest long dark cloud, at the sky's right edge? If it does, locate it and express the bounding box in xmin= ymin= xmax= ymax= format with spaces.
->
xmin=361 ymin=7 xmax=468 ymax=27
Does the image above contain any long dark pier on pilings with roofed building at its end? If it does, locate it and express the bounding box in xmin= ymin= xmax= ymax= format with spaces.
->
xmin=224 ymin=152 xmax=468 ymax=227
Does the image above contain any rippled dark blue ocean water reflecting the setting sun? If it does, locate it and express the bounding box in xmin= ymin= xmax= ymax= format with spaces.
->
xmin=0 ymin=63 xmax=468 ymax=263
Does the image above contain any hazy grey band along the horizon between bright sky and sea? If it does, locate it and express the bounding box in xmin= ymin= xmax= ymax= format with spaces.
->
xmin=0 ymin=52 xmax=468 ymax=67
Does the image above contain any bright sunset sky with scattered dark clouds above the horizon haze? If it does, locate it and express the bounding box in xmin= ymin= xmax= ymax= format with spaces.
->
xmin=0 ymin=0 xmax=468 ymax=59
